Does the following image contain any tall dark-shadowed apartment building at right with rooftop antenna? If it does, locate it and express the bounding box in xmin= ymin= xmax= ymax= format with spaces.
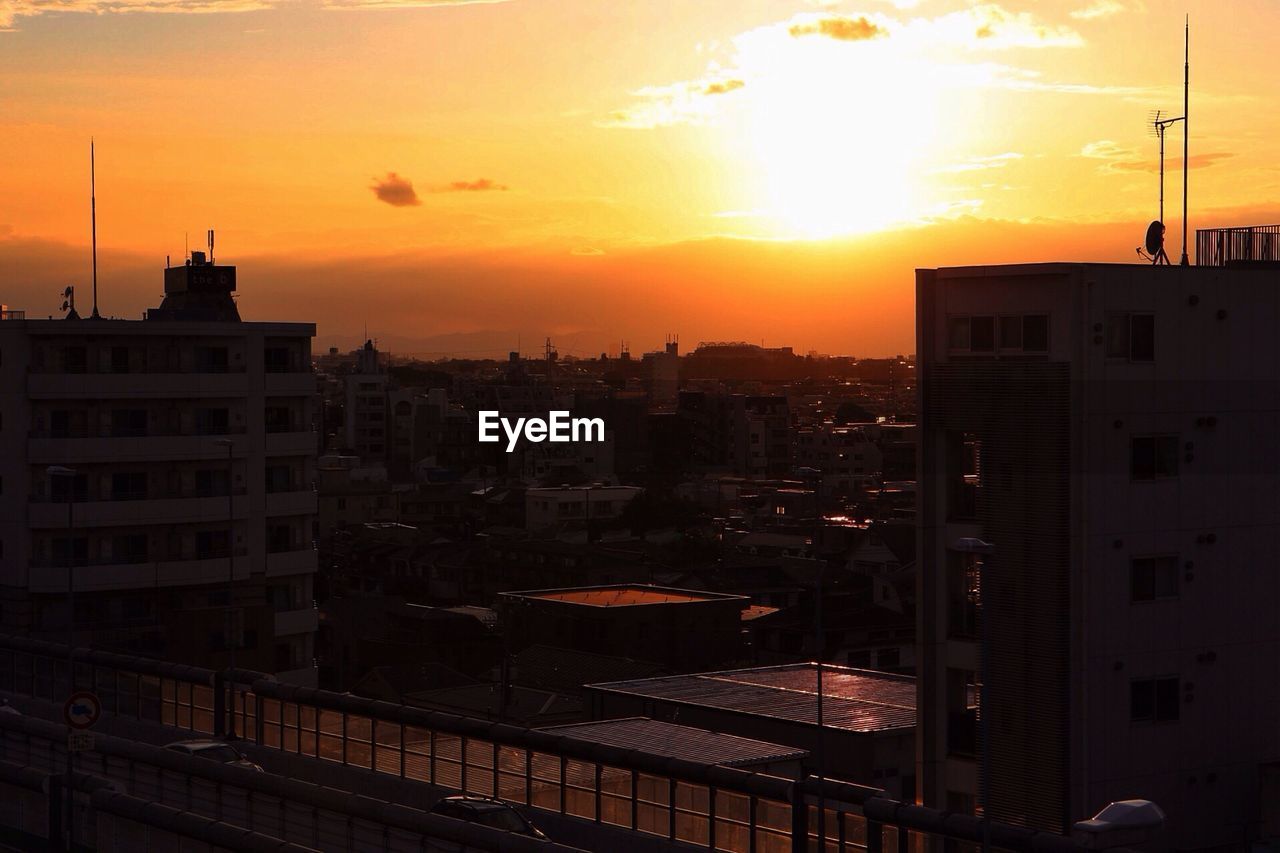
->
xmin=916 ymin=256 xmax=1280 ymax=850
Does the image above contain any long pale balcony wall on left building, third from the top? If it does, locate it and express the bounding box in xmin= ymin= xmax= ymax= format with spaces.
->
xmin=27 ymin=489 xmax=247 ymax=530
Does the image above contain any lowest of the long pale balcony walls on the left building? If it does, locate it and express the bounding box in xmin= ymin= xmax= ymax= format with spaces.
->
xmin=27 ymin=553 xmax=250 ymax=594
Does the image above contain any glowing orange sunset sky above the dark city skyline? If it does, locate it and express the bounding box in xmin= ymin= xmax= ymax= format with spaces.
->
xmin=0 ymin=0 xmax=1280 ymax=355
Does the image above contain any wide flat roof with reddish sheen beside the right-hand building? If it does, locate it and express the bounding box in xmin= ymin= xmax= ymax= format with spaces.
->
xmin=588 ymin=663 xmax=915 ymax=733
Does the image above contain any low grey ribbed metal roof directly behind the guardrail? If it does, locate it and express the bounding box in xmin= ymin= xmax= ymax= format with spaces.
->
xmin=545 ymin=717 xmax=809 ymax=767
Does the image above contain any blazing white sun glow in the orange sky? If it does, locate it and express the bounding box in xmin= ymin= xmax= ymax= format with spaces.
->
xmin=736 ymin=15 xmax=938 ymax=238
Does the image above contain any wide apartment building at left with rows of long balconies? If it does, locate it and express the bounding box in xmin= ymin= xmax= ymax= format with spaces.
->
xmin=0 ymin=252 xmax=316 ymax=683
